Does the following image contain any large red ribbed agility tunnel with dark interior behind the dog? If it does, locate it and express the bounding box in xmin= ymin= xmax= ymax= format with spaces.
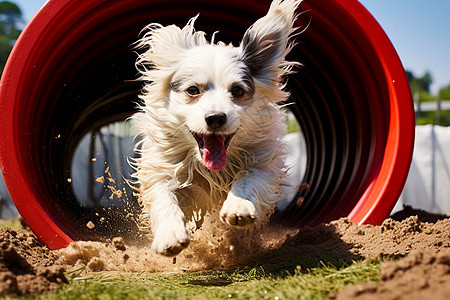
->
xmin=0 ymin=0 xmax=414 ymax=249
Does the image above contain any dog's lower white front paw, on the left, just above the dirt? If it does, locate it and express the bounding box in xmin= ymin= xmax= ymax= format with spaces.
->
xmin=152 ymin=224 xmax=191 ymax=256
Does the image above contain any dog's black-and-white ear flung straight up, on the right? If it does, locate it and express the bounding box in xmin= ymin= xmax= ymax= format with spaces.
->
xmin=240 ymin=0 xmax=301 ymax=80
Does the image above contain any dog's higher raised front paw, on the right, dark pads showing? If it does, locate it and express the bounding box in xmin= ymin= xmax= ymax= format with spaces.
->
xmin=220 ymin=197 xmax=258 ymax=228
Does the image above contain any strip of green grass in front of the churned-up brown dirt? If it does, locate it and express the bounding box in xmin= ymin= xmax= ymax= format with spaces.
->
xmin=22 ymin=262 xmax=379 ymax=300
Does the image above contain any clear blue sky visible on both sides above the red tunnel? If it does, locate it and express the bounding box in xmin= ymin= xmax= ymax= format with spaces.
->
xmin=11 ymin=0 xmax=450 ymax=92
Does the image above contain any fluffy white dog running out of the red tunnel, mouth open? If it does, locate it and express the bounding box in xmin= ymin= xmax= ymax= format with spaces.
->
xmin=132 ymin=0 xmax=301 ymax=256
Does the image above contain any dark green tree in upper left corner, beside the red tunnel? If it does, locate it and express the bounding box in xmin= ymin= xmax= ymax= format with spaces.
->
xmin=0 ymin=1 xmax=23 ymax=72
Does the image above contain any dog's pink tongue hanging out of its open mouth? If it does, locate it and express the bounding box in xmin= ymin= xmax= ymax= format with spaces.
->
xmin=202 ymin=134 xmax=227 ymax=171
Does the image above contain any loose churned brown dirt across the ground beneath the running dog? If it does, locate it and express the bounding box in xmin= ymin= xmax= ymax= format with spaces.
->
xmin=0 ymin=208 xmax=450 ymax=299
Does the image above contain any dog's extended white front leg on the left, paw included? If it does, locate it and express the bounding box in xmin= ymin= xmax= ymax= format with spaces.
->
xmin=142 ymin=189 xmax=190 ymax=256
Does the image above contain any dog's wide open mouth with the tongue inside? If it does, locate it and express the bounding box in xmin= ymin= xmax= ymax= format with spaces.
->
xmin=191 ymin=132 xmax=234 ymax=171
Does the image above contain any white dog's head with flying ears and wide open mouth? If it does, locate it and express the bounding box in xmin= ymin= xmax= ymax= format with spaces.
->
xmin=137 ymin=0 xmax=300 ymax=171
